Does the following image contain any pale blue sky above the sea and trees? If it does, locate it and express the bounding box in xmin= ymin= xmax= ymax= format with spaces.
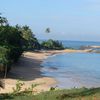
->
xmin=0 ymin=0 xmax=100 ymax=41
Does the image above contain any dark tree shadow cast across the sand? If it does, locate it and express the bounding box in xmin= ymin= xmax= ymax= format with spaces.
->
xmin=7 ymin=57 xmax=44 ymax=81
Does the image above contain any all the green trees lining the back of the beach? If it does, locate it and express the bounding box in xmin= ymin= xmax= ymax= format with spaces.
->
xmin=0 ymin=15 xmax=64 ymax=77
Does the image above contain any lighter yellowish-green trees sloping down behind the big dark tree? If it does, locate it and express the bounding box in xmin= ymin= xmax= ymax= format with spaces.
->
xmin=16 ymin=25 xmax=40 ymax=50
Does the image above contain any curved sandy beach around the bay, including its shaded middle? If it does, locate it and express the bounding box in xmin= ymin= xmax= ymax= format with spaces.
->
xmin=0 ymin=49 xmax=87 ymax=93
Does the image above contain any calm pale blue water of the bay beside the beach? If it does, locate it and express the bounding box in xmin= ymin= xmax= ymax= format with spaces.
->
xmin=41 ymin=53 xmax=100 ymax=88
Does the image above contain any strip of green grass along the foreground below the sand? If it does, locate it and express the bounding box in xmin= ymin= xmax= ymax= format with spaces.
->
xmin=0 ymin=88 xmax=100 ymax=100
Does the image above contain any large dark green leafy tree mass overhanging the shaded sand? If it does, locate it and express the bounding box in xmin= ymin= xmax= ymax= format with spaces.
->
xmin=0 ymin=25 xmax=23 ymax=70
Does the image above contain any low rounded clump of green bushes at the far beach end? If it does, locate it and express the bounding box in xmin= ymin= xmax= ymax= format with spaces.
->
xmin=41 ymin=39 xmax=64 ymax=50
